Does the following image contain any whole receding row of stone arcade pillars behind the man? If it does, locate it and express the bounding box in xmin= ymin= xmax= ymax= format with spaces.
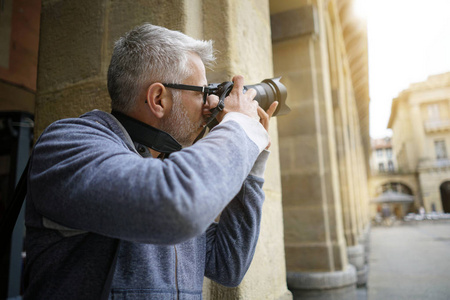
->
xmin=2 ymin=0 xmax=370 ymax=299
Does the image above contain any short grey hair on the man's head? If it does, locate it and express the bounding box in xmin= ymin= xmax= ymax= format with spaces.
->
xmin=108 ymin=23 xmax=215 ymax=113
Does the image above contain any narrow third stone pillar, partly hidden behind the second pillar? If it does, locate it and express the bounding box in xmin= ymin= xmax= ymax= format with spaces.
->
xmin=326 ymin=0 xmax=367 ymax=285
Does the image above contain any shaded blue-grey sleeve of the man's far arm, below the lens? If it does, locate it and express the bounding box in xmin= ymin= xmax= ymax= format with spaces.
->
xmin=205 ymin=154 xmax=267 ymax=287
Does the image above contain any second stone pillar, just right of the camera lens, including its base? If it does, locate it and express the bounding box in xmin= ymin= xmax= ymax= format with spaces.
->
xmin=272 ymin=0 xmax=356 ymax=299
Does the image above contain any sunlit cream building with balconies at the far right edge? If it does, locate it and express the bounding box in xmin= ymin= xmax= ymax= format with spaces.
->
xmin=388 ymin=73 xmax=450 ymax=213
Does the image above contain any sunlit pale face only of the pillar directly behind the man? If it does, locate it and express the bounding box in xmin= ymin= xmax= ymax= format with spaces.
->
xmin=203 ymin=0 xmax=292 ymax=299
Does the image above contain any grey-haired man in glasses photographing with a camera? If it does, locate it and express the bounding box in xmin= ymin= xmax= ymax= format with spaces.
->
xmin=24 ymin=24 xmax=277 ymax=299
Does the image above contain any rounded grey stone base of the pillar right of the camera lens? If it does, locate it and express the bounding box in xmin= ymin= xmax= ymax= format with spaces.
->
xmin=287 ymin=265 xmax=357 ymax=300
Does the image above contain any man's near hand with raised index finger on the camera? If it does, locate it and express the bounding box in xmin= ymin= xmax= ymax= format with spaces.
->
xmin=216 ymin=75 xmax=260 ymax=122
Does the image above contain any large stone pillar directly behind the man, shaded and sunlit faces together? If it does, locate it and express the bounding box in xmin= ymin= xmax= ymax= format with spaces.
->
xmin=36 ymin=0 xmax=292 ymax=299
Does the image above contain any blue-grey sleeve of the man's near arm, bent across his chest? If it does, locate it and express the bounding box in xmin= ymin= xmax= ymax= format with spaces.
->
xmin=27 ymin=112 xmax=268 ymax=244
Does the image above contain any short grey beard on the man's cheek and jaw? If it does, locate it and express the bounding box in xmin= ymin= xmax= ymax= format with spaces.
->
xmin=160 ymin=91 xmax=201 ymax=148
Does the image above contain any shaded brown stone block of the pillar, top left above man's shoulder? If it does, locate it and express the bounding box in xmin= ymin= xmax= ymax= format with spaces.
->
xmin=38 ymin=0 xmax=106 ymax=92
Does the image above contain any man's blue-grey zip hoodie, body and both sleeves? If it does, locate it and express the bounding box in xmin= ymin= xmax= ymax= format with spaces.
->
xmin=24 ymin=111 xmax=268 ymax=299
